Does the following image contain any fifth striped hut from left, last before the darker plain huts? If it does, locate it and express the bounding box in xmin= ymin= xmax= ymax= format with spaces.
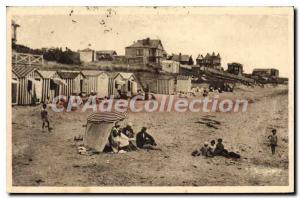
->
xmin=110 ymin=72 xmax=137 ymax=96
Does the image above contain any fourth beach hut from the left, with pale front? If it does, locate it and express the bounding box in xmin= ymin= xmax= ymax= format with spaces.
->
xmin=81 ymin=70 xmax=109 ymax=98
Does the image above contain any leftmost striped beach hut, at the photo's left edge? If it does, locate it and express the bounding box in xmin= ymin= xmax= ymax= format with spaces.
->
xmin=12 ymin=64 xmax=41 ymax=105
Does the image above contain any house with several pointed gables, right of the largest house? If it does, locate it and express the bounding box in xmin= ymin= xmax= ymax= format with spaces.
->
xmin=196 ymin=52 xmax=221 ymax=70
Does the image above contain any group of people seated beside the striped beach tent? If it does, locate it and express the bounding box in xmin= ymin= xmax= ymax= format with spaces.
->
xmin=104 ymin=122 xmax=159 ymax=153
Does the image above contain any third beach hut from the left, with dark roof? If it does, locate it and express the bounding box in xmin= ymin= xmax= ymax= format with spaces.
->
xmin=57 ymin=71 xmax=85 ymax=97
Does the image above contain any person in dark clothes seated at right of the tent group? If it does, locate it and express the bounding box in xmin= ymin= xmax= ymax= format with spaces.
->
xmin=136 ymin=127 xmax=157 ymax=149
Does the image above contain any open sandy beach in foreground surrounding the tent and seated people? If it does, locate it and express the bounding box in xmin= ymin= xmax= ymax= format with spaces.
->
xmin=12 ymin=85 xmax=289 ymax=186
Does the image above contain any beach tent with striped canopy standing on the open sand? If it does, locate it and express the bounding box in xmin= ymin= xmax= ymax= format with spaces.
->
xmin=84 ymin=112 xmax=127 ymax=152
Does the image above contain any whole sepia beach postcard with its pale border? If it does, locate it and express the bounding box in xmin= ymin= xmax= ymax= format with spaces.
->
xmin=6 ymin=6 xmax=295 ymax=193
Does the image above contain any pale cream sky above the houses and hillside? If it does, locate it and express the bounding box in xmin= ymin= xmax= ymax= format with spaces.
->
xmin=12 ymin=7 xmax=293 ymax=76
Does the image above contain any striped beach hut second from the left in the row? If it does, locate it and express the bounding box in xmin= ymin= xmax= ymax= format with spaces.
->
xmin=37 ymin=70 xmax=66 ymax=102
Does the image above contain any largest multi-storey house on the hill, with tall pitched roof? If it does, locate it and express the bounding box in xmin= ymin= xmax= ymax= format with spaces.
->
xmin=125 ymin=38 xmax=166 ymax=65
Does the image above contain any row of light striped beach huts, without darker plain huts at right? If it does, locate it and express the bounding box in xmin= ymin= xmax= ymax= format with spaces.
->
xmin=11 ymin=64 xmax=138 ymax=105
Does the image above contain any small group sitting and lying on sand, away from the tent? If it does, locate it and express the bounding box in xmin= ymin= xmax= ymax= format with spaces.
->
xmin=192 ymin=138 xmax=241 ymax=159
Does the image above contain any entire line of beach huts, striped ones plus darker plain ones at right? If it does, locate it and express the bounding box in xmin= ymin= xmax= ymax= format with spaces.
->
xmin=11 ymin=64 xmax=192 ymax=105
